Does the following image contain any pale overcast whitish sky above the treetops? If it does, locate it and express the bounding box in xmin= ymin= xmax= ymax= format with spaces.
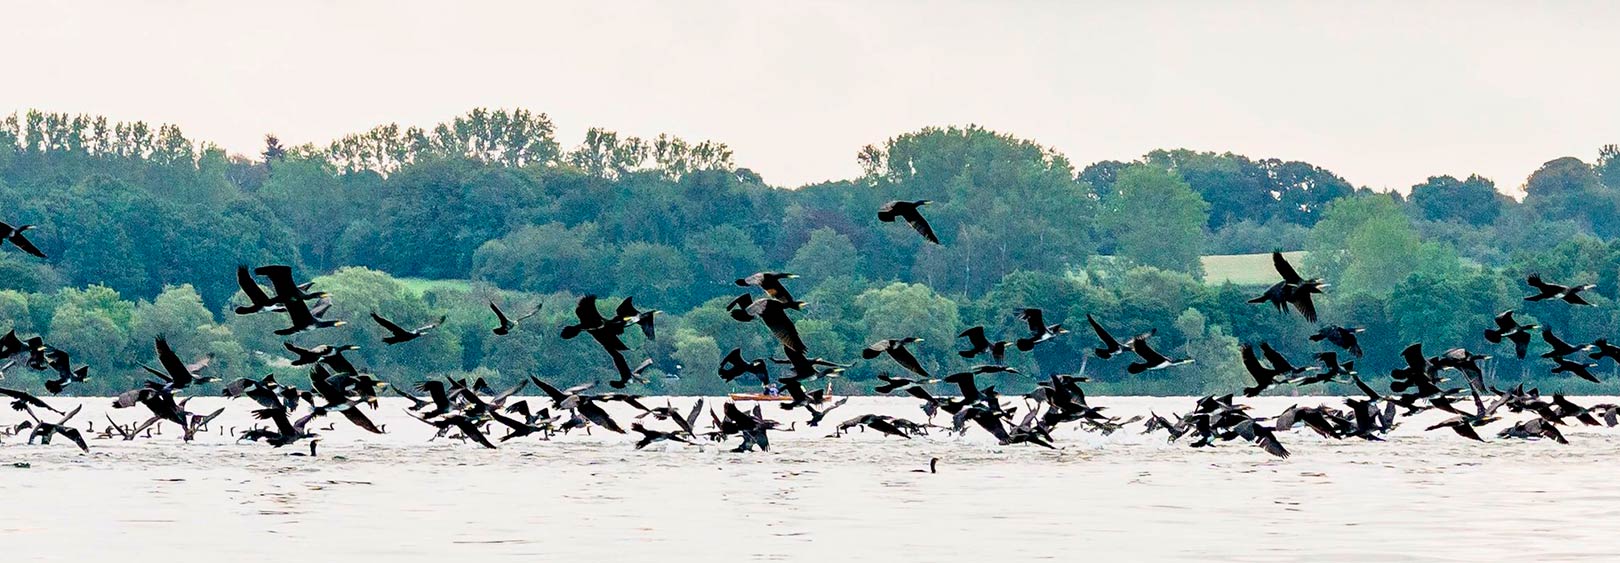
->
xmin=0 ymin=0 xmax=1620 ymax=191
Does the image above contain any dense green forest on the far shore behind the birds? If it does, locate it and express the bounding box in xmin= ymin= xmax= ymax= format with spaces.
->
xmin=0 ymin=110 xmax=1620 ymax=395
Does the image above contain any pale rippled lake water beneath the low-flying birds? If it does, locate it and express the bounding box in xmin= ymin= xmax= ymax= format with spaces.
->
xmin=0 ymin=396 xmax=1620 ymax=561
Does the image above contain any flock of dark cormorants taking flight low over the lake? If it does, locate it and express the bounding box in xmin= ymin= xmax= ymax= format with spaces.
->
xmin=0 ymin=201 xmax=1620 ymax=462
